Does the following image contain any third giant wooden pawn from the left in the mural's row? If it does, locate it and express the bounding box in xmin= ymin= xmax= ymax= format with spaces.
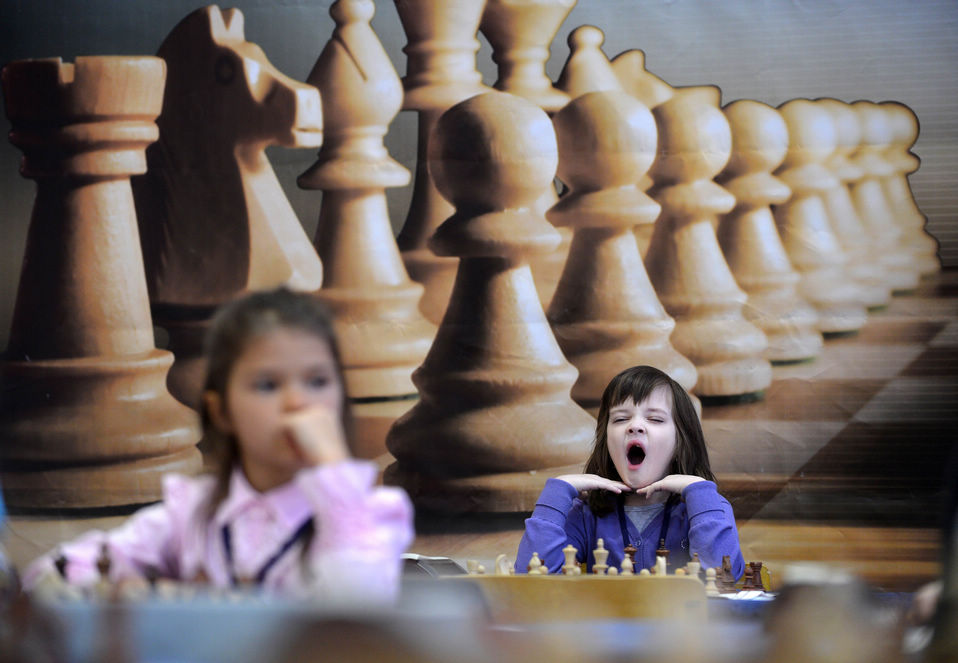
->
xmin=645 ymin=87 xmax=772 ymax=399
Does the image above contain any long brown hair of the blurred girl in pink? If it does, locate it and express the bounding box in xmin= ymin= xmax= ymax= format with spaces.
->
xmin=200 ymin=287 xmax=353 ymax=518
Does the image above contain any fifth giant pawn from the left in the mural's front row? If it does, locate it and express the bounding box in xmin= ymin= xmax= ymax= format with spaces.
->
xmin=774 ymin=99 xmax=866 ymax=334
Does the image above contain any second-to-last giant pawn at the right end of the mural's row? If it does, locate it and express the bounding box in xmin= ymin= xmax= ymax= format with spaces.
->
xmin=851 ymin=101 xmax=919 ymax=294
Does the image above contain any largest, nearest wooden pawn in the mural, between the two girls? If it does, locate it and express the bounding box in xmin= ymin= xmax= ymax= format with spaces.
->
xmin=385 ymin=92 xmax=595 ymax=512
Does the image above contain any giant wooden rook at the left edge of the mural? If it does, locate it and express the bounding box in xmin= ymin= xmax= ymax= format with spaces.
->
xmin=0 ymin=56 xmax=200 ymax=509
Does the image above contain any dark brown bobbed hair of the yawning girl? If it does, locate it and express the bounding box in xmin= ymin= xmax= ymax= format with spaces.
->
xmin=583 ymin=366 xmax=715 ymax=516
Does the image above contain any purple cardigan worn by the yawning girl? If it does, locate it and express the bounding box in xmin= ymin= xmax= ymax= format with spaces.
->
xmin=516 ymin=479 xmax=745 ymax=578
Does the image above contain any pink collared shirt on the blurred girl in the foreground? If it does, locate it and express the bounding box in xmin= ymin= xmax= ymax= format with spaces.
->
xmin=23 ymin=460 xmax=413 ymax=602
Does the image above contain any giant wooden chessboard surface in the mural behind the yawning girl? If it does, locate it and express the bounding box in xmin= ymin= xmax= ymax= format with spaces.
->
xmin=413 ymin=271 xmax=958 ymax=591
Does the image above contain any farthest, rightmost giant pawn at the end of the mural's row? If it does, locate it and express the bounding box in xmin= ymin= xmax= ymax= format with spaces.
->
xmin=878 ymin=101 xmax=941 ymax=276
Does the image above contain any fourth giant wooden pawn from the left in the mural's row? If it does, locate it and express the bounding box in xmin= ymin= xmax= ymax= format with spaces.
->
xmin=717 ymin=99 xmax=823 ymax=362
